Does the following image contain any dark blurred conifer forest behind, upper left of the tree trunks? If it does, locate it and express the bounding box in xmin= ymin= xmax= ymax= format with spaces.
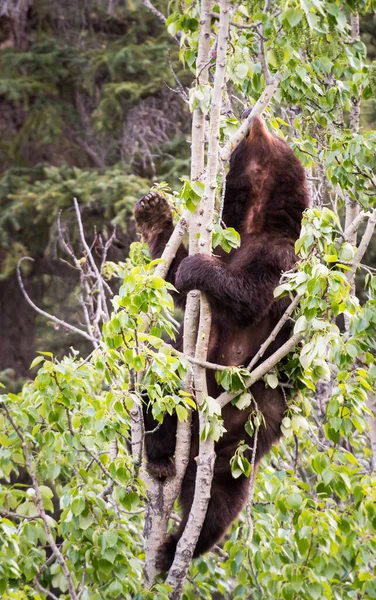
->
xmin=0 ymin=0 xmax=190 ymax=387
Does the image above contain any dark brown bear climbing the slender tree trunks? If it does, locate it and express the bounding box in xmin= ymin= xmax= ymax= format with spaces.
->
xmin=135 ymin=117 xmax=309 ymax=572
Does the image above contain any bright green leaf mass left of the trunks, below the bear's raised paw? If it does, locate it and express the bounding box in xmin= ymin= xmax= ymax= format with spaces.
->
xmin=0 ymin=244 xmax=195 ymax=600
